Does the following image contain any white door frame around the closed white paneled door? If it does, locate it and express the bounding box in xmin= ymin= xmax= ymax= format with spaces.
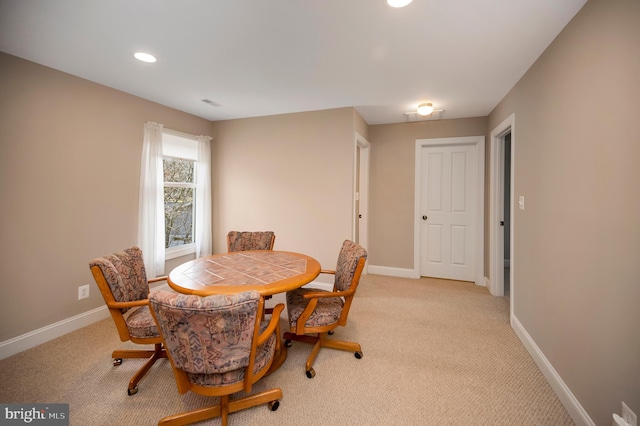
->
xmin=412 ymin=136 xmax=485 ymax=285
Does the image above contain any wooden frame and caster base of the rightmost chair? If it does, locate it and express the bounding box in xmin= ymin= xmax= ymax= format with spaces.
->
xmin=284 ymin=257 xmax=367 ymax=379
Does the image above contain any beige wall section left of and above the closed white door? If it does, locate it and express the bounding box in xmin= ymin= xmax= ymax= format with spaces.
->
xmin=369 ymin=117 xmax=487 ymax=269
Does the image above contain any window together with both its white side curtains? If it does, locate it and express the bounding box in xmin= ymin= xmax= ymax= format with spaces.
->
xmin=138 ymin=121 xmax=211 ymax=277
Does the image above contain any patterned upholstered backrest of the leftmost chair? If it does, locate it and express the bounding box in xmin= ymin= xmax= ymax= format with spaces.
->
xmin=89 ymin=247 xmax=149 ymax=311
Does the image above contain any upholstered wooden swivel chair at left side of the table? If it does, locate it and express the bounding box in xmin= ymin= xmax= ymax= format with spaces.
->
xmin=89 ymin=247 xmax=167 ymax=395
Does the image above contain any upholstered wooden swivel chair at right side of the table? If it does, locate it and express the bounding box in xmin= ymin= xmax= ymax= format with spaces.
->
xmin=284 ymin=240 xmax=367 ymax=379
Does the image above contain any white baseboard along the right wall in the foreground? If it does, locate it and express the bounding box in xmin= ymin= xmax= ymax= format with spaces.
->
xmin=511 ymin=315 xmax=595 ymax=426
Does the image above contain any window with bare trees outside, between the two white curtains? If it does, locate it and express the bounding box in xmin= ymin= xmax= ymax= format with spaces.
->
xmin=162 ymin=129 xmax=198 ymax=259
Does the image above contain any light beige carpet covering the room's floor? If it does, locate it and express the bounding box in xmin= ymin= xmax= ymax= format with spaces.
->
xmin=0 ymin=275 xmax=573 ymax=426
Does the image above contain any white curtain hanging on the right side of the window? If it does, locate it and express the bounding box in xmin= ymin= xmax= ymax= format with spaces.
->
xmin=195 ymin=136 xmax=212 ymax=258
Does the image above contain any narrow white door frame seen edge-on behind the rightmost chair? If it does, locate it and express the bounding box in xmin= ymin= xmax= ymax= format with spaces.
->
xmin=352 ymin=132 xmax=371 ymax=274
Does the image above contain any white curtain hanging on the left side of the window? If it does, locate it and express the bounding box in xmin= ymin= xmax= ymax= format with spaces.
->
xmin=138 ymin=122 xmax=165 ymax=278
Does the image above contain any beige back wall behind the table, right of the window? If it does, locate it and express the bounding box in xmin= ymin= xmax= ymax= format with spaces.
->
xmin=213 ymin=108 xmax=361 ymax=269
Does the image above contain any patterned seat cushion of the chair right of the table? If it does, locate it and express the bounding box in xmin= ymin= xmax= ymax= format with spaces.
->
xmin=287 ymin=288 xmax=344 ymax=329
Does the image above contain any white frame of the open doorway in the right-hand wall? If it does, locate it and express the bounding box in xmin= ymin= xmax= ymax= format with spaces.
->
xmin=488 ymin=114 xmax=516 ymax=304
